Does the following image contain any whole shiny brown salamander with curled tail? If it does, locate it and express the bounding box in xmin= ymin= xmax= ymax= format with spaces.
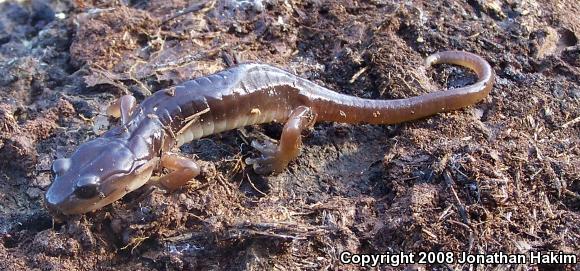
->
xmin=45 ymin=51 xmax=494 ymax=215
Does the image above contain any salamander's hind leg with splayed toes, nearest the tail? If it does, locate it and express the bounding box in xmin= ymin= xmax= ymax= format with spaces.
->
xmin=246 ymin=106 xmax=316 ymax=174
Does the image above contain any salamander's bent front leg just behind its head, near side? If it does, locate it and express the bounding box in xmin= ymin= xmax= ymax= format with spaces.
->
xmin=158 ymin=152 xmax=200 ymax=190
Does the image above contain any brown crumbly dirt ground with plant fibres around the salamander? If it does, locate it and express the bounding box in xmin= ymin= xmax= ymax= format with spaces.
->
xmin=0 ymin=0 xmax=580 ymax=270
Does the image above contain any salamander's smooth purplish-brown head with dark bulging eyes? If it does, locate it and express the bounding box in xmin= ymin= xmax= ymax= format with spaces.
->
xmin=45 ymin=138 xmax=154 ymax=216
